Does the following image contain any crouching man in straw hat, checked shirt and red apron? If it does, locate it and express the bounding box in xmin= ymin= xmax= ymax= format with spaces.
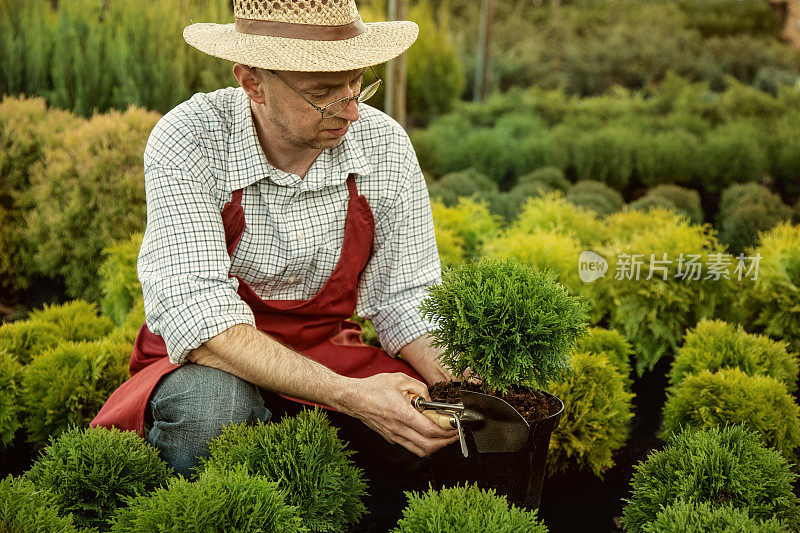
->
xmin=92 ymin=0 xmax=466 ymax=524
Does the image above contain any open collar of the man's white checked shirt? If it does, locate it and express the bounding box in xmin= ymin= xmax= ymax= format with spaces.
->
xmin=226 ymin=87 xmax=370 ymax=193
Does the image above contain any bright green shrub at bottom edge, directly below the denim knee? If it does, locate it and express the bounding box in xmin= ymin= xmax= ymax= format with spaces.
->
xmin=111 ymin=468 xmax=309 ymax=533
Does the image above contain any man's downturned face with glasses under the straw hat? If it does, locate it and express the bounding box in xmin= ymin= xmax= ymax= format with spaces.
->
xmin=259 ymin=69 xmax=366 ymax=150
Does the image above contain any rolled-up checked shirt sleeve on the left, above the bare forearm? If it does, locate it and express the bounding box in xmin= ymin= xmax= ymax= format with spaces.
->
xmin=137 ymin=165 xmax=255 ymax=364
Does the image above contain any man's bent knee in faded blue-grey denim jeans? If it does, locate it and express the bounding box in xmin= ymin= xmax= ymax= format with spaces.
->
xmin=147 ymin=364 xmax=271 ymax=477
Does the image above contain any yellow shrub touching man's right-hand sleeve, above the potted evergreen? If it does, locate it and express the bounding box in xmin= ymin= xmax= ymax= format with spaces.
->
xmin=431 ymin=198 xmax=500 ymax=259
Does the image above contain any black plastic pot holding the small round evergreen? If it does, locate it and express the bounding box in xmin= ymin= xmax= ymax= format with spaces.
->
xmin=431 ymin=391 xmax=564 ymax=510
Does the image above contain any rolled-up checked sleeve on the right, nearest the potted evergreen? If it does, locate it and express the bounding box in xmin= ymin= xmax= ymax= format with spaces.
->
xmin=357 ymin=134 xmax=441 ymax=357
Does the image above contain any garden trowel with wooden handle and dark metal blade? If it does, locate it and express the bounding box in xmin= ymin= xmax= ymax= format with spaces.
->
xmin=409 ymin=390 xmax=530 ymax=457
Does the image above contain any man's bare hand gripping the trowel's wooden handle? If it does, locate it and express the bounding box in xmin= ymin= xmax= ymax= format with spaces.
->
xmin=343 ymin=372 xmax=458 ymax=457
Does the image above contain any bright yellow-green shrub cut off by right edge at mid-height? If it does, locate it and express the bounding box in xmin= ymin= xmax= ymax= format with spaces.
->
xmin=739 ymin=223 xmax=800 ymax=353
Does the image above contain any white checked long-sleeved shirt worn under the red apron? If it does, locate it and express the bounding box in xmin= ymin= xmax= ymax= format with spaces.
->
xmin=137 ymin=87 xmax=441 ymax=364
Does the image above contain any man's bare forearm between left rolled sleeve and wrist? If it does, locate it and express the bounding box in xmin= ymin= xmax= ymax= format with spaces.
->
xmin=187 ymin=324 xmax=351 ymax=412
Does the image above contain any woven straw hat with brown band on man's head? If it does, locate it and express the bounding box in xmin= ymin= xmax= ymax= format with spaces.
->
xmin=183 ymin=0 xmax=419 ymax=72
